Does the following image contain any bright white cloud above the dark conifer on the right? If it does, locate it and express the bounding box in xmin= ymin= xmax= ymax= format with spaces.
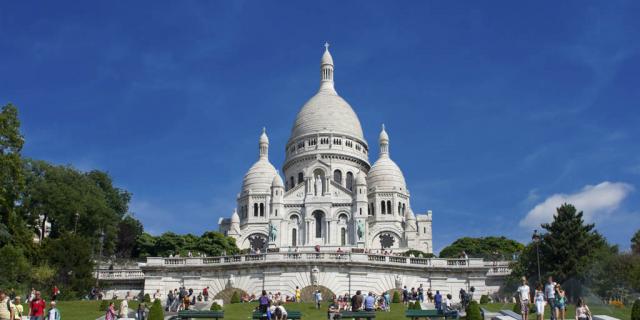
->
xmin=520 ymin=181 xmax=633 ymax=228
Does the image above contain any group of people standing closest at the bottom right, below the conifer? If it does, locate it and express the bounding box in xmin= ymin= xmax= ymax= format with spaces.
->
xmin=516 ymin=277 xmax=591 ymax=320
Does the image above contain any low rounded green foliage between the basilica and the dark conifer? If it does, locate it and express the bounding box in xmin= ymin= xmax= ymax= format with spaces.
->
xmin=440 ymin=237 xmax=524 ymax=260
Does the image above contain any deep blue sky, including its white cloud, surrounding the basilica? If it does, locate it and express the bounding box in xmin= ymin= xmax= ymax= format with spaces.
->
xmin=0 ymin=1 xmax=640 ymax=254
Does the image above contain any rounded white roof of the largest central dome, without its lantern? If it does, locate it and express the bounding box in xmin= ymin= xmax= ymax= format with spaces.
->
xmin=291 ymin=90 xmax=365 ymax=141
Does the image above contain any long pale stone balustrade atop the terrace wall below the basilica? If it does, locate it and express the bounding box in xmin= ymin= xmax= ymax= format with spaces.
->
xmin=143 ymin=252 xmax=489 ymax=269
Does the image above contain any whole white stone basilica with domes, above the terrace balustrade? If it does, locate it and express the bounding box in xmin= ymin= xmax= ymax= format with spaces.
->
xmin=218 ymin=45 xmax=433 ymax=253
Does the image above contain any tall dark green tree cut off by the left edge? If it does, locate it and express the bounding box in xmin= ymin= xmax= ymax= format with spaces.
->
xmin=0 ymin=104 xmax=24 ymax=241
